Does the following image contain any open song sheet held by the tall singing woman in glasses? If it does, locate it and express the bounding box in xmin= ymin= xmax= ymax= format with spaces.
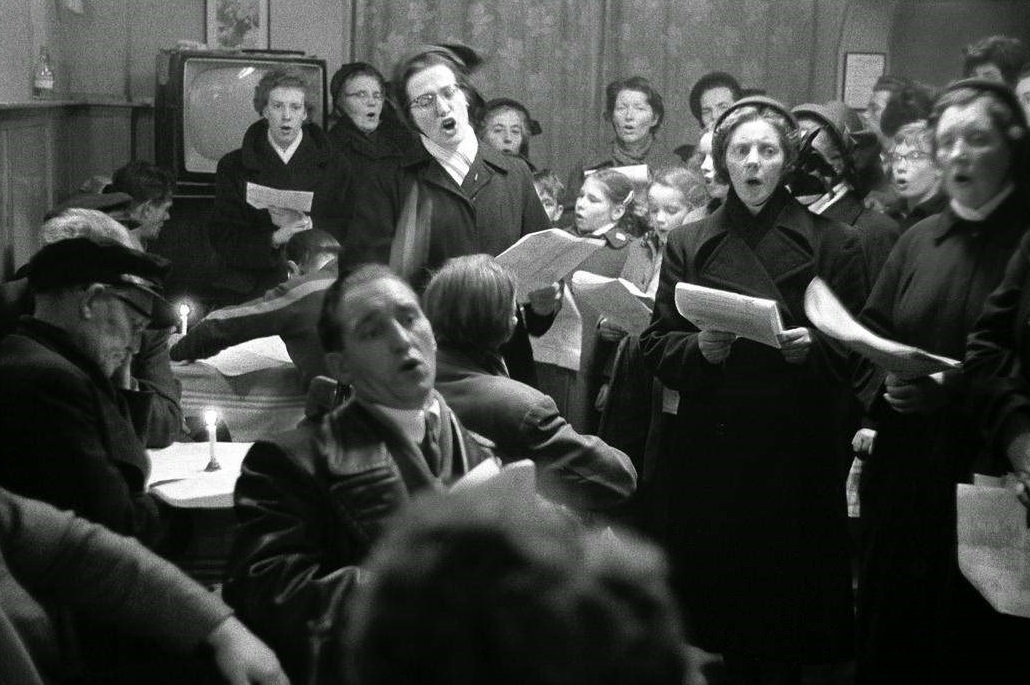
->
xmin=496 ymin=229 xmax=605 ymax=302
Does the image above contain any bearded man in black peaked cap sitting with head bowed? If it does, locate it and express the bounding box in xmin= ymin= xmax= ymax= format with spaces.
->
xmin=0 ymin=238 xmax=174 ymax=547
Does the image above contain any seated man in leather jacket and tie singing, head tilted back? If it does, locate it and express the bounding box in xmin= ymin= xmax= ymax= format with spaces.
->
xmin=224 ymin=265 xmax=491 ymax=683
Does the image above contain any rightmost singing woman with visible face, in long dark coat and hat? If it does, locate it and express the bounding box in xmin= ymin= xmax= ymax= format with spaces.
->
xmin=856 ymin=79 xmax=1030 ymax=685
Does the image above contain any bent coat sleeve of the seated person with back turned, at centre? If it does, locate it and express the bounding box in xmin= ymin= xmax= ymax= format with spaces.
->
xmin=508 ymin=397 xmax=637 ymax=510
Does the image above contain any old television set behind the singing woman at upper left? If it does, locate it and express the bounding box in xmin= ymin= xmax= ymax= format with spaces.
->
xmin=153 ymin=49 xmax=328 ymax=196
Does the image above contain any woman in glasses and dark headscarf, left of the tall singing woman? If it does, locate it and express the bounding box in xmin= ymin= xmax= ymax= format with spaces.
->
xmin=329 ymin=62 xmax=418 ymax=179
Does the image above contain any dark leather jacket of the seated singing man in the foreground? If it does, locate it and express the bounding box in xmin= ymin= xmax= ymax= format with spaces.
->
xmin=224 ymin=399 xmax=490 ymax=683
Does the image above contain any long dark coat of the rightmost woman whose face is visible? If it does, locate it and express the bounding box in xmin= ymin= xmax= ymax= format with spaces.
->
xmin=858 ymin=192 xmax=1030 ymax=683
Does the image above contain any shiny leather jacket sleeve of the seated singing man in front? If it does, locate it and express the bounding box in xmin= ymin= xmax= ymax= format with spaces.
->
xmin=222 ymin=442 xmax=359 ymax=682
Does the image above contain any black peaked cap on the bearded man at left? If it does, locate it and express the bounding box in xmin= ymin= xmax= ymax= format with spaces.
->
xmin=14 ymin=238 xmax=176 ymax=329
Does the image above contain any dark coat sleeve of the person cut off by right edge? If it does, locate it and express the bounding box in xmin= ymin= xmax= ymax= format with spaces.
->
xmin=964 ymin=229 xmax=1030 ymax=459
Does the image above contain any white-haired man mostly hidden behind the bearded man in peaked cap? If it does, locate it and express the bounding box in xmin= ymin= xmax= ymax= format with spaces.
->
xmin=0 ymin=206 xmax=183 ymax=447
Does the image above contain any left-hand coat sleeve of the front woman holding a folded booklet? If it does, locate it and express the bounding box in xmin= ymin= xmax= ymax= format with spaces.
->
xmin=641 ymin=234 xmax=708 ymax=389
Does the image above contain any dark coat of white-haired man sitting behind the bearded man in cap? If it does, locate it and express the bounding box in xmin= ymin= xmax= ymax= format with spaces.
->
xmin=0 ymin=280 xmax=184 ymax=447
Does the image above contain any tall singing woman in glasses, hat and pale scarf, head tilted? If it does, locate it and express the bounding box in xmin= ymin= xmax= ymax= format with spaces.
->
xmin=342 ymin=45 xmax=557 ymax=384
